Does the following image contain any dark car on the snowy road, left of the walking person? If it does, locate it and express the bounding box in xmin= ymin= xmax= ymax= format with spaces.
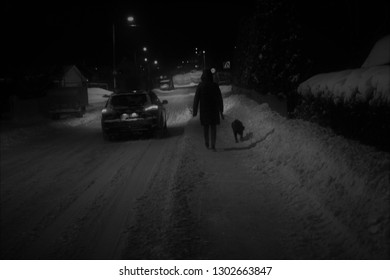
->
xmin=101 ymin=90 xmax=168 ymax=139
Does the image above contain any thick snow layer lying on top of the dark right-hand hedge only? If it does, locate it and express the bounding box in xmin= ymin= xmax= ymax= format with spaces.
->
xmin=298 ymin=65 xmax=390 ymax=105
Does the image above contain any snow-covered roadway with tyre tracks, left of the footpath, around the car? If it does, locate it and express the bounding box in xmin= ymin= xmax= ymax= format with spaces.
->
xmin=1 ymin=88 xmax=192 ymax=259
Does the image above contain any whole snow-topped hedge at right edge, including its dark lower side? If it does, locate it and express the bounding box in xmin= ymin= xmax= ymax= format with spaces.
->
xmin=295 ymin=36 xmax=390 ymax=149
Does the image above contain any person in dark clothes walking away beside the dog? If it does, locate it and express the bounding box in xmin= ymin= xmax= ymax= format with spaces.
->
xmin=192 ymin=69 xmax=224 ymax=151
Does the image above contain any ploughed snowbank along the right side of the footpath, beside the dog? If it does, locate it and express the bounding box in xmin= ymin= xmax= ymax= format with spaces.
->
xmin=179 ymin=89 xmax=390 ymax=259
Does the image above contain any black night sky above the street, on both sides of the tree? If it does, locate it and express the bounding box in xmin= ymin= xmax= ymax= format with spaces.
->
xmin=1 ymin=0 xmax=390 ymax=74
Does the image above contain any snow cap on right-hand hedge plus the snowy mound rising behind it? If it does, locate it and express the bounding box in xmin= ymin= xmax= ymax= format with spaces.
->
xmin=298 ymin=35 xmax=390 ymax=106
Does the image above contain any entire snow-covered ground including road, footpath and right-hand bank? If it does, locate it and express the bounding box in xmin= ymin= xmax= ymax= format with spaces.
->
xmin=0 ymin=86 xmax=390 ymax=259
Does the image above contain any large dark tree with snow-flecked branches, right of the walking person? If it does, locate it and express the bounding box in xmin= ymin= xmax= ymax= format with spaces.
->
xmin=234 ymin=0 xmax=303 ymax=95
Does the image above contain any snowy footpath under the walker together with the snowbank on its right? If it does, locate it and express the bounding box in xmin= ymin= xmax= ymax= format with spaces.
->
xmin=126 ymin=88 xmax=390 ymax=259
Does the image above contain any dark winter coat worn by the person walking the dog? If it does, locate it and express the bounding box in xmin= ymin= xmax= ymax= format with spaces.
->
xmin=192 ymin=79 xmax=223 ymax=125
